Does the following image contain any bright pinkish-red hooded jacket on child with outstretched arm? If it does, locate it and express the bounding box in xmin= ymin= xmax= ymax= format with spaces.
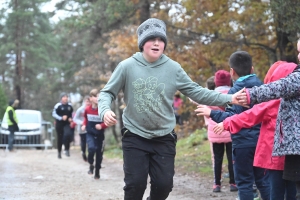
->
xmin=223 ymin=62 xmax=296 ymax=170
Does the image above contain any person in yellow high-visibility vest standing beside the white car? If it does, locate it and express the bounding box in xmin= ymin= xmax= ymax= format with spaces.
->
xmin=5 ymin=99 xmax=19 ymax=152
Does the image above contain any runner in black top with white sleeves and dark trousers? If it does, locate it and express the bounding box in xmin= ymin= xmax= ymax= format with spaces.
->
xmin=52 ymin=93 xmax=73 ymax=159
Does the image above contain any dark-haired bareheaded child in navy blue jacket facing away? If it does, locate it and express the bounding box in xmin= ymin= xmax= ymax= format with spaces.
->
xmin=195 ymin=51 xmax=270 ymax=200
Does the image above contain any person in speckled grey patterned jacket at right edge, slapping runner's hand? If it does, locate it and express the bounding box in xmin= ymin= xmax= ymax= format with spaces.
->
xmin=239 ymin=39 xmax=300 ymax=200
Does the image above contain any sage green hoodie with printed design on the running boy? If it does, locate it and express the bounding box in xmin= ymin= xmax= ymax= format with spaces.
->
xmin=98 ymin=52 xmax=232 ymax=139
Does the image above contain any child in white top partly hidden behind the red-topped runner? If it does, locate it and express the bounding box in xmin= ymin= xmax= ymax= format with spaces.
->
xmin=73 ymin=96 xmax=91 ymax=162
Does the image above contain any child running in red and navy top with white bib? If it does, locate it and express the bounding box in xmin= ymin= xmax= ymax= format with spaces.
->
xmin=81 ymin=89 xmax=107 ymax=179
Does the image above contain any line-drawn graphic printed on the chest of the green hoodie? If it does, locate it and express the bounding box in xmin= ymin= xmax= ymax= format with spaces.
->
xmin=132 ymin=76 xmax=165 ymax=113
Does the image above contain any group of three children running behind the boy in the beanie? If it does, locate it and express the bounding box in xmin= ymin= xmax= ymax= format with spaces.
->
xmin=52 ymin=89 xmax=107 ymax=179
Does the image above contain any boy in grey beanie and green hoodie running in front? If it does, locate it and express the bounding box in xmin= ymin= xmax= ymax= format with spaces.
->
xmin=98 ymin=18 xmax=246 ymax=200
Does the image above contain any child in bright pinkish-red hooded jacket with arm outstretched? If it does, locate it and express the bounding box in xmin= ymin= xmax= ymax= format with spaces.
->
xmin=214 ymin=61 xmax=297 ymax=200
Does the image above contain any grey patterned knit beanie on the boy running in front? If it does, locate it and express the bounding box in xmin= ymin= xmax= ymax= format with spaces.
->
xmin=136 ymin=18 xmax=167 ymax=51
